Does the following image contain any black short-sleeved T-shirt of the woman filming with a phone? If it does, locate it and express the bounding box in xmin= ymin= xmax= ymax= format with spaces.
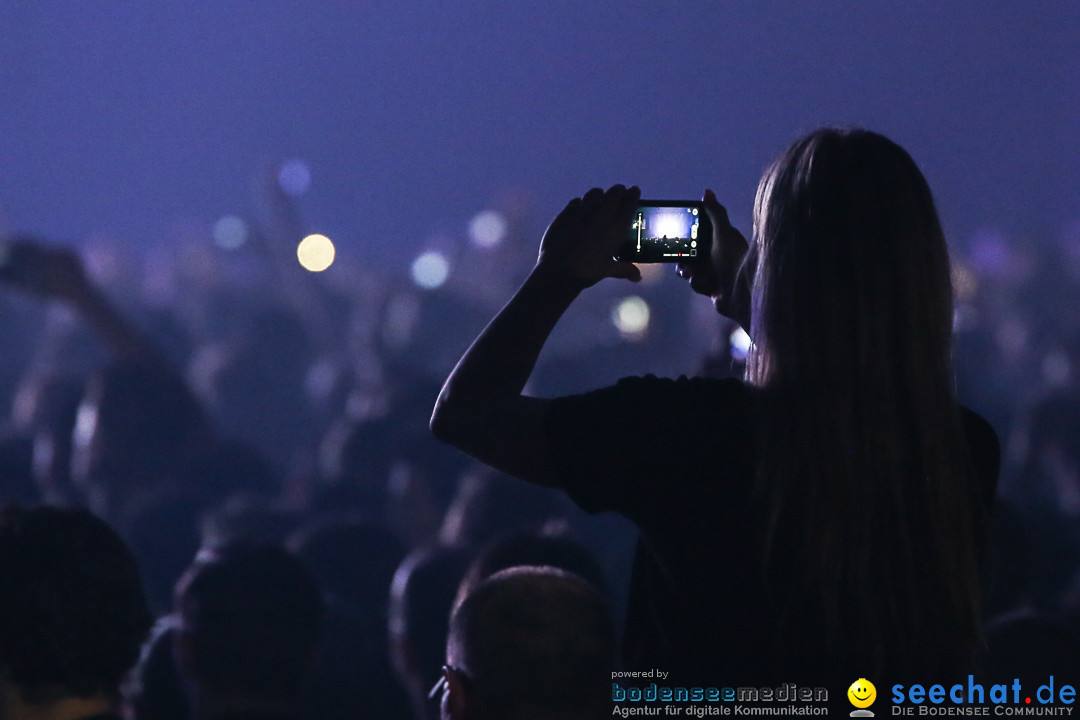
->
xmin=546 ymin=376 xmax=999 ymax=692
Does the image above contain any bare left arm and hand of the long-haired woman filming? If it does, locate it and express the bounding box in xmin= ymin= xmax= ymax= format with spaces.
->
xmin=431 ymin=185 xmax=640 ymax=487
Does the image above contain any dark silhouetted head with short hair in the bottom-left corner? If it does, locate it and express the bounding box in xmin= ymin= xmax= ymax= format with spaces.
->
xmin=0 ymin=507 xmax=151 ymax=704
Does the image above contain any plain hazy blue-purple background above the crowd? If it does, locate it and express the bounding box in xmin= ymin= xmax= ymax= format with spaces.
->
xmin=0 ymin=0 xmax=1080 ymax=266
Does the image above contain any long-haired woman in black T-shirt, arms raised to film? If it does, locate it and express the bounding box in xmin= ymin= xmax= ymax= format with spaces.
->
xmin=432 ymin=128 xmax=998 ymax=687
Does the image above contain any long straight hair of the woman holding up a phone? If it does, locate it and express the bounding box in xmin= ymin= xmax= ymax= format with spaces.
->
xmin=747 ymin=128 xmax=983 ymax=677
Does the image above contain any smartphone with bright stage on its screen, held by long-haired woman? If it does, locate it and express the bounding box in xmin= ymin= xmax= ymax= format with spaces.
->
xmin=615 ymin=200 xmax=713 ymax=262
